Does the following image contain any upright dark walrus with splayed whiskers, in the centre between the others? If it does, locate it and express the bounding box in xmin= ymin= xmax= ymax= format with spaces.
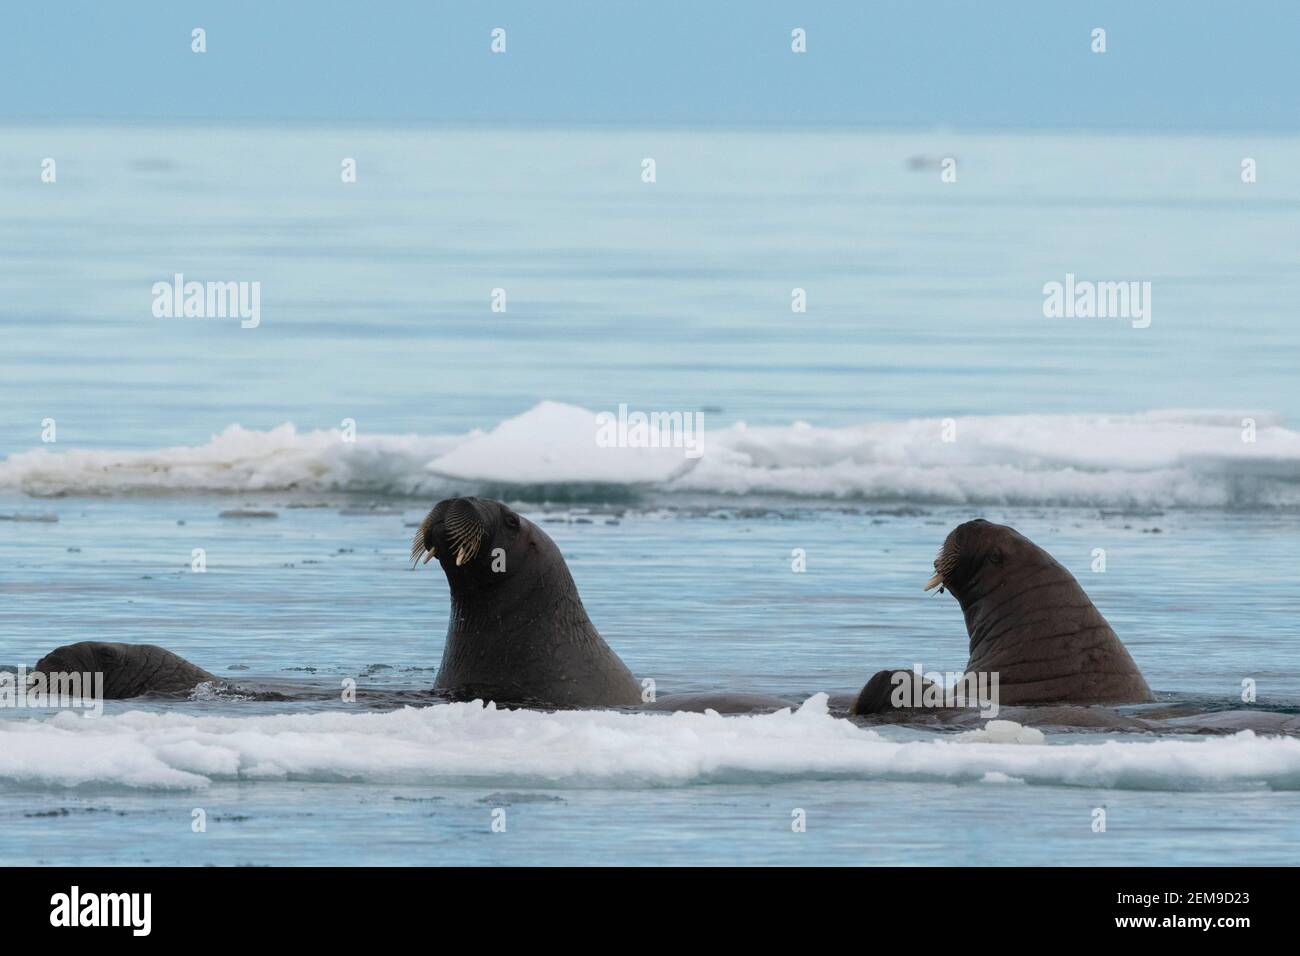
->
xmin=411 ymin=497 xmax=641 ymax=708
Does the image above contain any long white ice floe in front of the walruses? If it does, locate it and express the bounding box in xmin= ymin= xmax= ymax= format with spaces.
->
xmin=0 ymin=695 xmax=1300 ymax=791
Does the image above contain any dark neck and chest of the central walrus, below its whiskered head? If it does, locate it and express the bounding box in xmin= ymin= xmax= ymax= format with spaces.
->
xmin=436 ymin=541 xmax=641 ymax=708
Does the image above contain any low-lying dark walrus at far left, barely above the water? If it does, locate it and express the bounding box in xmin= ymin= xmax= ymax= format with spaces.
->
xmin=33 ymin=641 xmax=220 ymax=700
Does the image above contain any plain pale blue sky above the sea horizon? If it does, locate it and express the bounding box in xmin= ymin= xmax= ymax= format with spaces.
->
xmin=0 ymin=0 xmax=1300 ymax=130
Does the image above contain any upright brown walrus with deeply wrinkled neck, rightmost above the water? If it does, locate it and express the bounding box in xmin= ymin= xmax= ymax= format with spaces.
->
xmin=926 ymin=518 xmax=1153 ymax=705
